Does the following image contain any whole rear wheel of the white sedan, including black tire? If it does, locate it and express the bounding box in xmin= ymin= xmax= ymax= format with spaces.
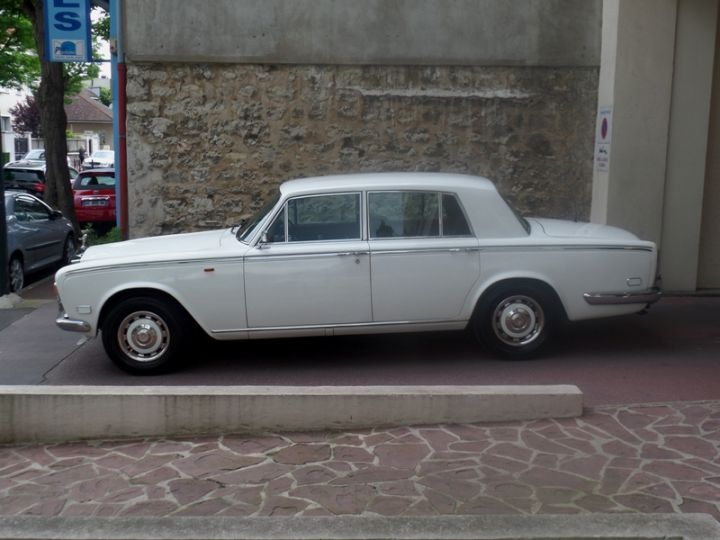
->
xmin=473 ymin=284 xmax=561 ymax=360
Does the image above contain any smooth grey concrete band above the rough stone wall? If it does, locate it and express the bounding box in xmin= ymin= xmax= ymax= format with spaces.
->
xmin=123 ymin=0 xmax=602 ymax=66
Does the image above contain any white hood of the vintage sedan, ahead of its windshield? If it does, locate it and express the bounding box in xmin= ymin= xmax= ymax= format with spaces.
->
xmin=81 ymin=229 xmax=229 ymax=262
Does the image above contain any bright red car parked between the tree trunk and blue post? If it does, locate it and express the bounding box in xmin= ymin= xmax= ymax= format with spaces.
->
xmin=73 ymin=169 xmax=115 ymax=229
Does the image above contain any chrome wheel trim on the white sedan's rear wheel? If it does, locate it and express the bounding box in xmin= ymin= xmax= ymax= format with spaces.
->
xmin=492 ymin=295 xmax=545 ymax=347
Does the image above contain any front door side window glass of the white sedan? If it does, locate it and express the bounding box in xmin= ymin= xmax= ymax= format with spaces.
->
xmin=267 ymin=193 xmax=362 ymax=242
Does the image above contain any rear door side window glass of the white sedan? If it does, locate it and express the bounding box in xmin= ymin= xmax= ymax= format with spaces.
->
xmin=368 ymin=191 xmax=472 ymax=238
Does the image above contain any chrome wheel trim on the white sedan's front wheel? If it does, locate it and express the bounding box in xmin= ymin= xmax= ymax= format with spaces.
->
xmin=117 ymin=311 xmax=170 ymax=363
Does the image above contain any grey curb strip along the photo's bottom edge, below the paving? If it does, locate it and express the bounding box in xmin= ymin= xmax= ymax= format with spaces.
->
xmin=0 ymin=514 xmax=720 ymax=540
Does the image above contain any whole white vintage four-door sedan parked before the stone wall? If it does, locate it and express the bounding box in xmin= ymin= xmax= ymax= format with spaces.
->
xmin=56 ymin=173 xmax=660 ymax=373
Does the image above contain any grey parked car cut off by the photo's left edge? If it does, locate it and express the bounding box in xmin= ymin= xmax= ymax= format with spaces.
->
xmin=5 ymin=191 xmax=75 ymax=292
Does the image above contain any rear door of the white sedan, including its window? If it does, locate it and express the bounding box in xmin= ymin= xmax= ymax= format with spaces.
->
xmin=367 ymin=191 xmax=480 ymax=323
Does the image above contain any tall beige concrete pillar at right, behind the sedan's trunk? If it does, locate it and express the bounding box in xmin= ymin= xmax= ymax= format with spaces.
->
xmin=591 ymin=0 xmax=718 ymax=291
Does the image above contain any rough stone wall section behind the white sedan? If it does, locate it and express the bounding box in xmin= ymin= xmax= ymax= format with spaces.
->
xmin=127 ymin=63 xmax=598 ymax=237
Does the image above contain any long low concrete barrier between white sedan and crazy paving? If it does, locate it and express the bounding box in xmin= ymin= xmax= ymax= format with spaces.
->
xmin=0 ymin=385 xmax=582 ymax=443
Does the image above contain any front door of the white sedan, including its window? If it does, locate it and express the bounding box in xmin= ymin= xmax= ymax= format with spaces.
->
xmin=245 ymin=193 xmax=372 ymax=330
